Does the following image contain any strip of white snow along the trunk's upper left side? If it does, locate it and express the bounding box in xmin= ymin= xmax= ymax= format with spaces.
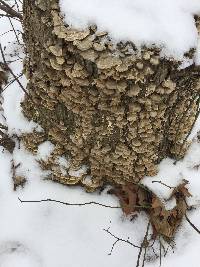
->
xmin=0 ymin=18 xmax=40 ymax=135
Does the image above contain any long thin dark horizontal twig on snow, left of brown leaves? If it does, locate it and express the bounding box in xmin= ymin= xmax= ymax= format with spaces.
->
xmin=18 ymin=198 xmax=121 ymax=209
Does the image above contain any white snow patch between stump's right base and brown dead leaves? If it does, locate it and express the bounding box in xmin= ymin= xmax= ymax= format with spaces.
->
xmin=142 ymin=138 xmax=200 ymax=205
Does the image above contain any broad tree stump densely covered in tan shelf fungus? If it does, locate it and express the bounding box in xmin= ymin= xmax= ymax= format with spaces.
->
xmin=22 ymin=0 xmax=200 ymax=193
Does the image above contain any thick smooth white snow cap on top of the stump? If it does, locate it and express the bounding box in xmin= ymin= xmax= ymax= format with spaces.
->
xmin=60 ymin=0 xmax=200 ymax=59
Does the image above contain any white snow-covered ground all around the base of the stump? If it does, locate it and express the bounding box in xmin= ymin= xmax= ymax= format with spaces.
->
xmin=0 ymin=0 xmax=200 ymax=267
